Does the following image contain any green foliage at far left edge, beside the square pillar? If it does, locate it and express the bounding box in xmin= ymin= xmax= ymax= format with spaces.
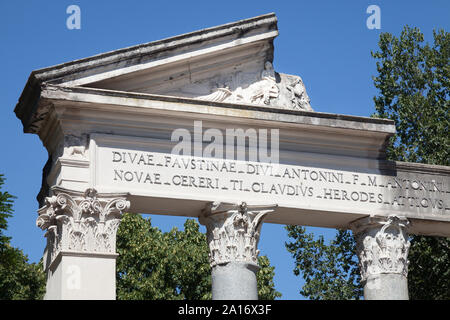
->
xmin=0 ymin=174 xmax=45 ymax=300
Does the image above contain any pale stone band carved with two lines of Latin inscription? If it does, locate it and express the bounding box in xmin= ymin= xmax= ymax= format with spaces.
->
xmin=109 ymin=149 xmax=450 ymax=214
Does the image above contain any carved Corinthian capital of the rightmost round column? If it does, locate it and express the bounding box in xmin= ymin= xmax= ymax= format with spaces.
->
xmin=351 ymin=215 xmax=410 ymax=282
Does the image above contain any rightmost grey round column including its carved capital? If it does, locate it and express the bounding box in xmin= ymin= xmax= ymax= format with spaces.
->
xmin=351 ymin=215 xmax=410 ymax=300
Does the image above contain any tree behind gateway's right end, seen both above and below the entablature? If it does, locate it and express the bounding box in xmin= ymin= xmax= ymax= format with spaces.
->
xmin=286 ymin=26 xmax=450 ymax=299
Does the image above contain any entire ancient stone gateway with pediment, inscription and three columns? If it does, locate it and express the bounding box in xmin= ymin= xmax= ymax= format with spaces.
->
xmin=15 ymin=14 xmax=450 ymax=299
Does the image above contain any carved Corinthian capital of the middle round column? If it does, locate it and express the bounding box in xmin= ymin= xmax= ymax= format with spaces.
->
xmin=199 ymin=202 xmax=276 ymax=267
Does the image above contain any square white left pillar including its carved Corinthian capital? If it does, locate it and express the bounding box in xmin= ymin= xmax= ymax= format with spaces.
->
xmin=36 ymin=188 xmax=130 ymax=300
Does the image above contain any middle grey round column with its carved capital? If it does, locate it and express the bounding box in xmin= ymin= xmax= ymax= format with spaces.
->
xmin=199 ymin=202 xmax=276 ymax=300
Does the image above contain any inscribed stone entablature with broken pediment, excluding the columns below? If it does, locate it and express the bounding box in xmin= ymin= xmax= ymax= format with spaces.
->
xmin=15 ymin=14 xmax=450 ymax=236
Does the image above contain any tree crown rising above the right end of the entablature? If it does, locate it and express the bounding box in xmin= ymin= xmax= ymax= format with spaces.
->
xmin=372 ymin=26 xmax=450 ymax=166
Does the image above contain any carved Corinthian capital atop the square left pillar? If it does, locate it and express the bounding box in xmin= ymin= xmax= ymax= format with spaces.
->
xmin=36 ymin=188 xmax=130 ymax=269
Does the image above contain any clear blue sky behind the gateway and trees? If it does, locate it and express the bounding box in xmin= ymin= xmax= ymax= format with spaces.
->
xmin=0 ymin=0 xmax=450 ymax=299
